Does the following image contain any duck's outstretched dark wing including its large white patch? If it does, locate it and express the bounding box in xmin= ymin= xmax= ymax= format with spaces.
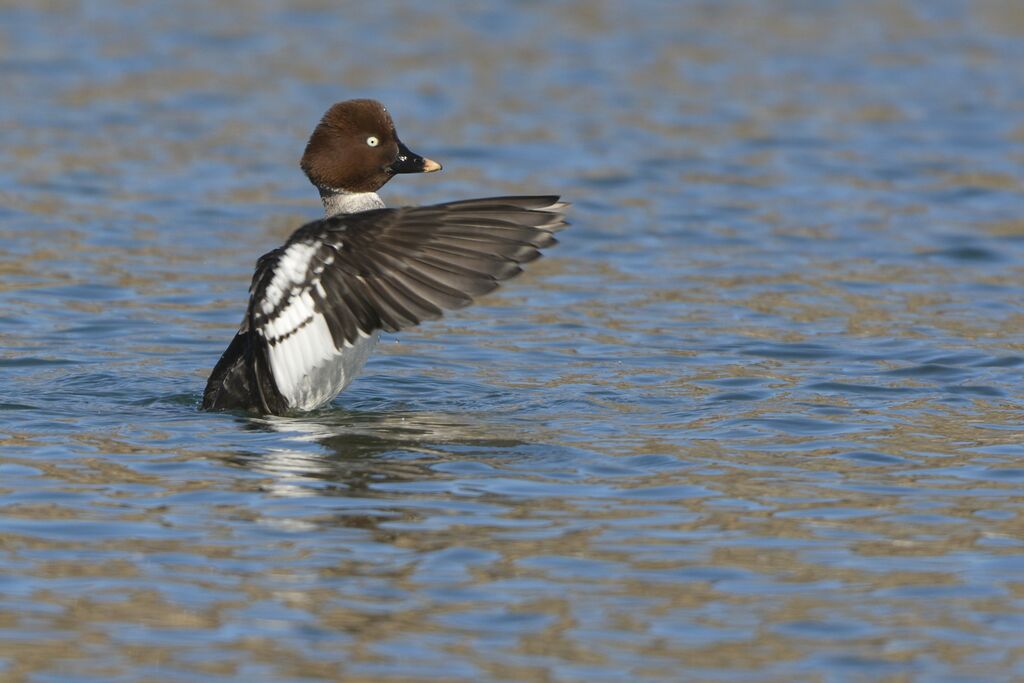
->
xmin=248 ymin=197 xmax=566 ymax=413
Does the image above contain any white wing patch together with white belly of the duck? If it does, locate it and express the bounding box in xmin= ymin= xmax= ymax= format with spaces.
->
xmin=256 ymin=242 xmax=378 ymax=411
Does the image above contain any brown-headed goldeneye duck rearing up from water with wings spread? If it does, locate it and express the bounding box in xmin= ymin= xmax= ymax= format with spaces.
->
xmin=203 ymin=99 xmax=567 ymax=415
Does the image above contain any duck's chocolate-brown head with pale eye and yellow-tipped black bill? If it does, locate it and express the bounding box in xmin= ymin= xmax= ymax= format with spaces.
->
xmin=300 ymin=99 xmax=441 ymax=195
